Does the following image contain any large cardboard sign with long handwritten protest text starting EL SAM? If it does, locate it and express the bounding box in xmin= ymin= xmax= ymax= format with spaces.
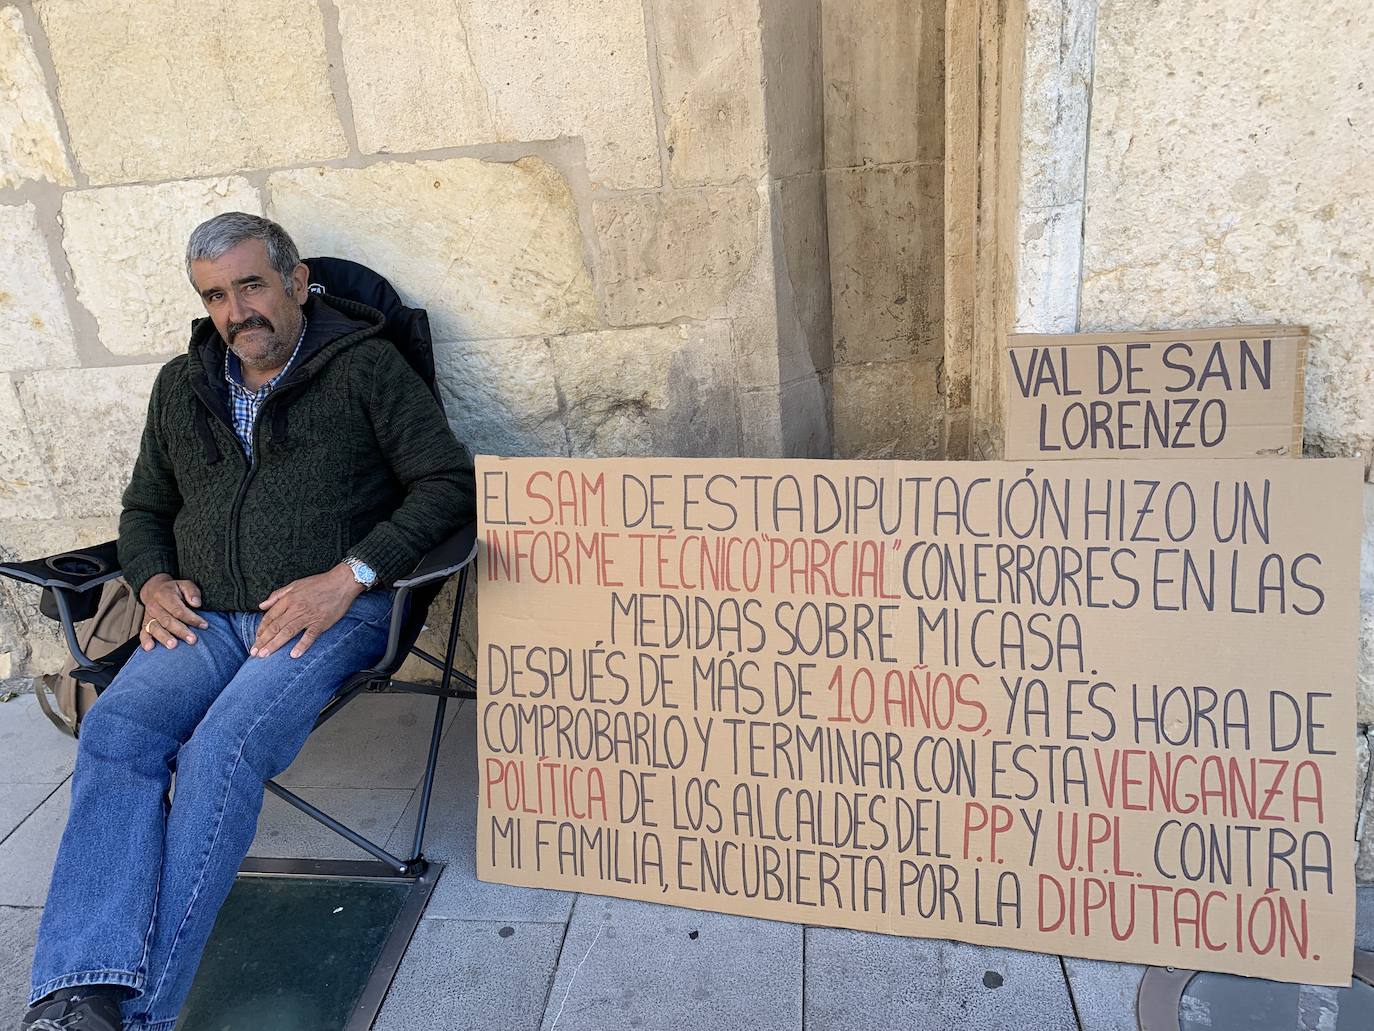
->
xmin=477 ymin=456 xmax=1362 ymax=984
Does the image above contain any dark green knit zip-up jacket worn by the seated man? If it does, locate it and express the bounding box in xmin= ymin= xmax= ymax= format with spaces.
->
xmin=120 ymin=297 xmax=477 ymax=612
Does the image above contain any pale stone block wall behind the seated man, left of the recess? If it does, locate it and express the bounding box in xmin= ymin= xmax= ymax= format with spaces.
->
xmin=0 ymin=0 xmax=830 ymax=690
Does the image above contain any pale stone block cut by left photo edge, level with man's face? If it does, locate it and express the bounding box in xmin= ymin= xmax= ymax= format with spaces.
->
xmin=0 ymin=203 xmax=77 ymax=371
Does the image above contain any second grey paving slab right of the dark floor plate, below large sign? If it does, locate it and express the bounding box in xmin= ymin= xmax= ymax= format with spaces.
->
xmin=543 ymin=895 xmax=802 ymax=1031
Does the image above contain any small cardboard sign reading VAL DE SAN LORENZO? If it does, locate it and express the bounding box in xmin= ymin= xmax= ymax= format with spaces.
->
xmin=1003 ymin=326 xmax=1307 ymax=459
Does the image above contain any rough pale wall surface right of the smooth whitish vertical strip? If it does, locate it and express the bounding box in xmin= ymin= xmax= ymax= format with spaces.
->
xmin=1083 ymin=0 xmax=1374 ymax=454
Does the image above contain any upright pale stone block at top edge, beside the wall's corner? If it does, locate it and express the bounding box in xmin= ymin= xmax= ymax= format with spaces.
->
xmin=653 ymin=0 xmax=768 ymax=186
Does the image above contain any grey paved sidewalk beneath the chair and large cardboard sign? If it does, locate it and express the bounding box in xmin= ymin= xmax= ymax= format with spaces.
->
xmin=0 ymin=696 xmax=1374 ymax=1031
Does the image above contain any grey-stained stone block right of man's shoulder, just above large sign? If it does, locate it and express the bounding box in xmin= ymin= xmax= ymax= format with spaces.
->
xmin=434 ymin=337 xmax=567 ymax=455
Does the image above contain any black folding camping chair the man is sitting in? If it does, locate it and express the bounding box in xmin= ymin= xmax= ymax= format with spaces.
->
xmin=0 ymin=257 xmax=477 ymax=878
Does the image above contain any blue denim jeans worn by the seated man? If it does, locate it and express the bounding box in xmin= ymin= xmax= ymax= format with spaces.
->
xmin=29 ymin=590 xmax=394 ymax=1031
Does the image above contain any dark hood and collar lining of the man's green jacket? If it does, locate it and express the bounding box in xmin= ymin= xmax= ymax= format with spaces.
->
xmin=187 ymin=294 xmax=386 ymax=463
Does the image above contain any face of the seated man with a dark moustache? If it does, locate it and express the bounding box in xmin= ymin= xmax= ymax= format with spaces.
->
xmin=191 ymin=239 xmax=309 ymax=371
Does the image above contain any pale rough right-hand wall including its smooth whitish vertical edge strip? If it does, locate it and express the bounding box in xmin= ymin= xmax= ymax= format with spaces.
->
xmin=1015 ymin=0 xmax=1374 ymax=880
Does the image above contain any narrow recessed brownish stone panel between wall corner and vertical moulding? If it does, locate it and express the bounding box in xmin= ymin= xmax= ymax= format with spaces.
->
xmin=820 ymin=0 xmax=947 ymax=458
